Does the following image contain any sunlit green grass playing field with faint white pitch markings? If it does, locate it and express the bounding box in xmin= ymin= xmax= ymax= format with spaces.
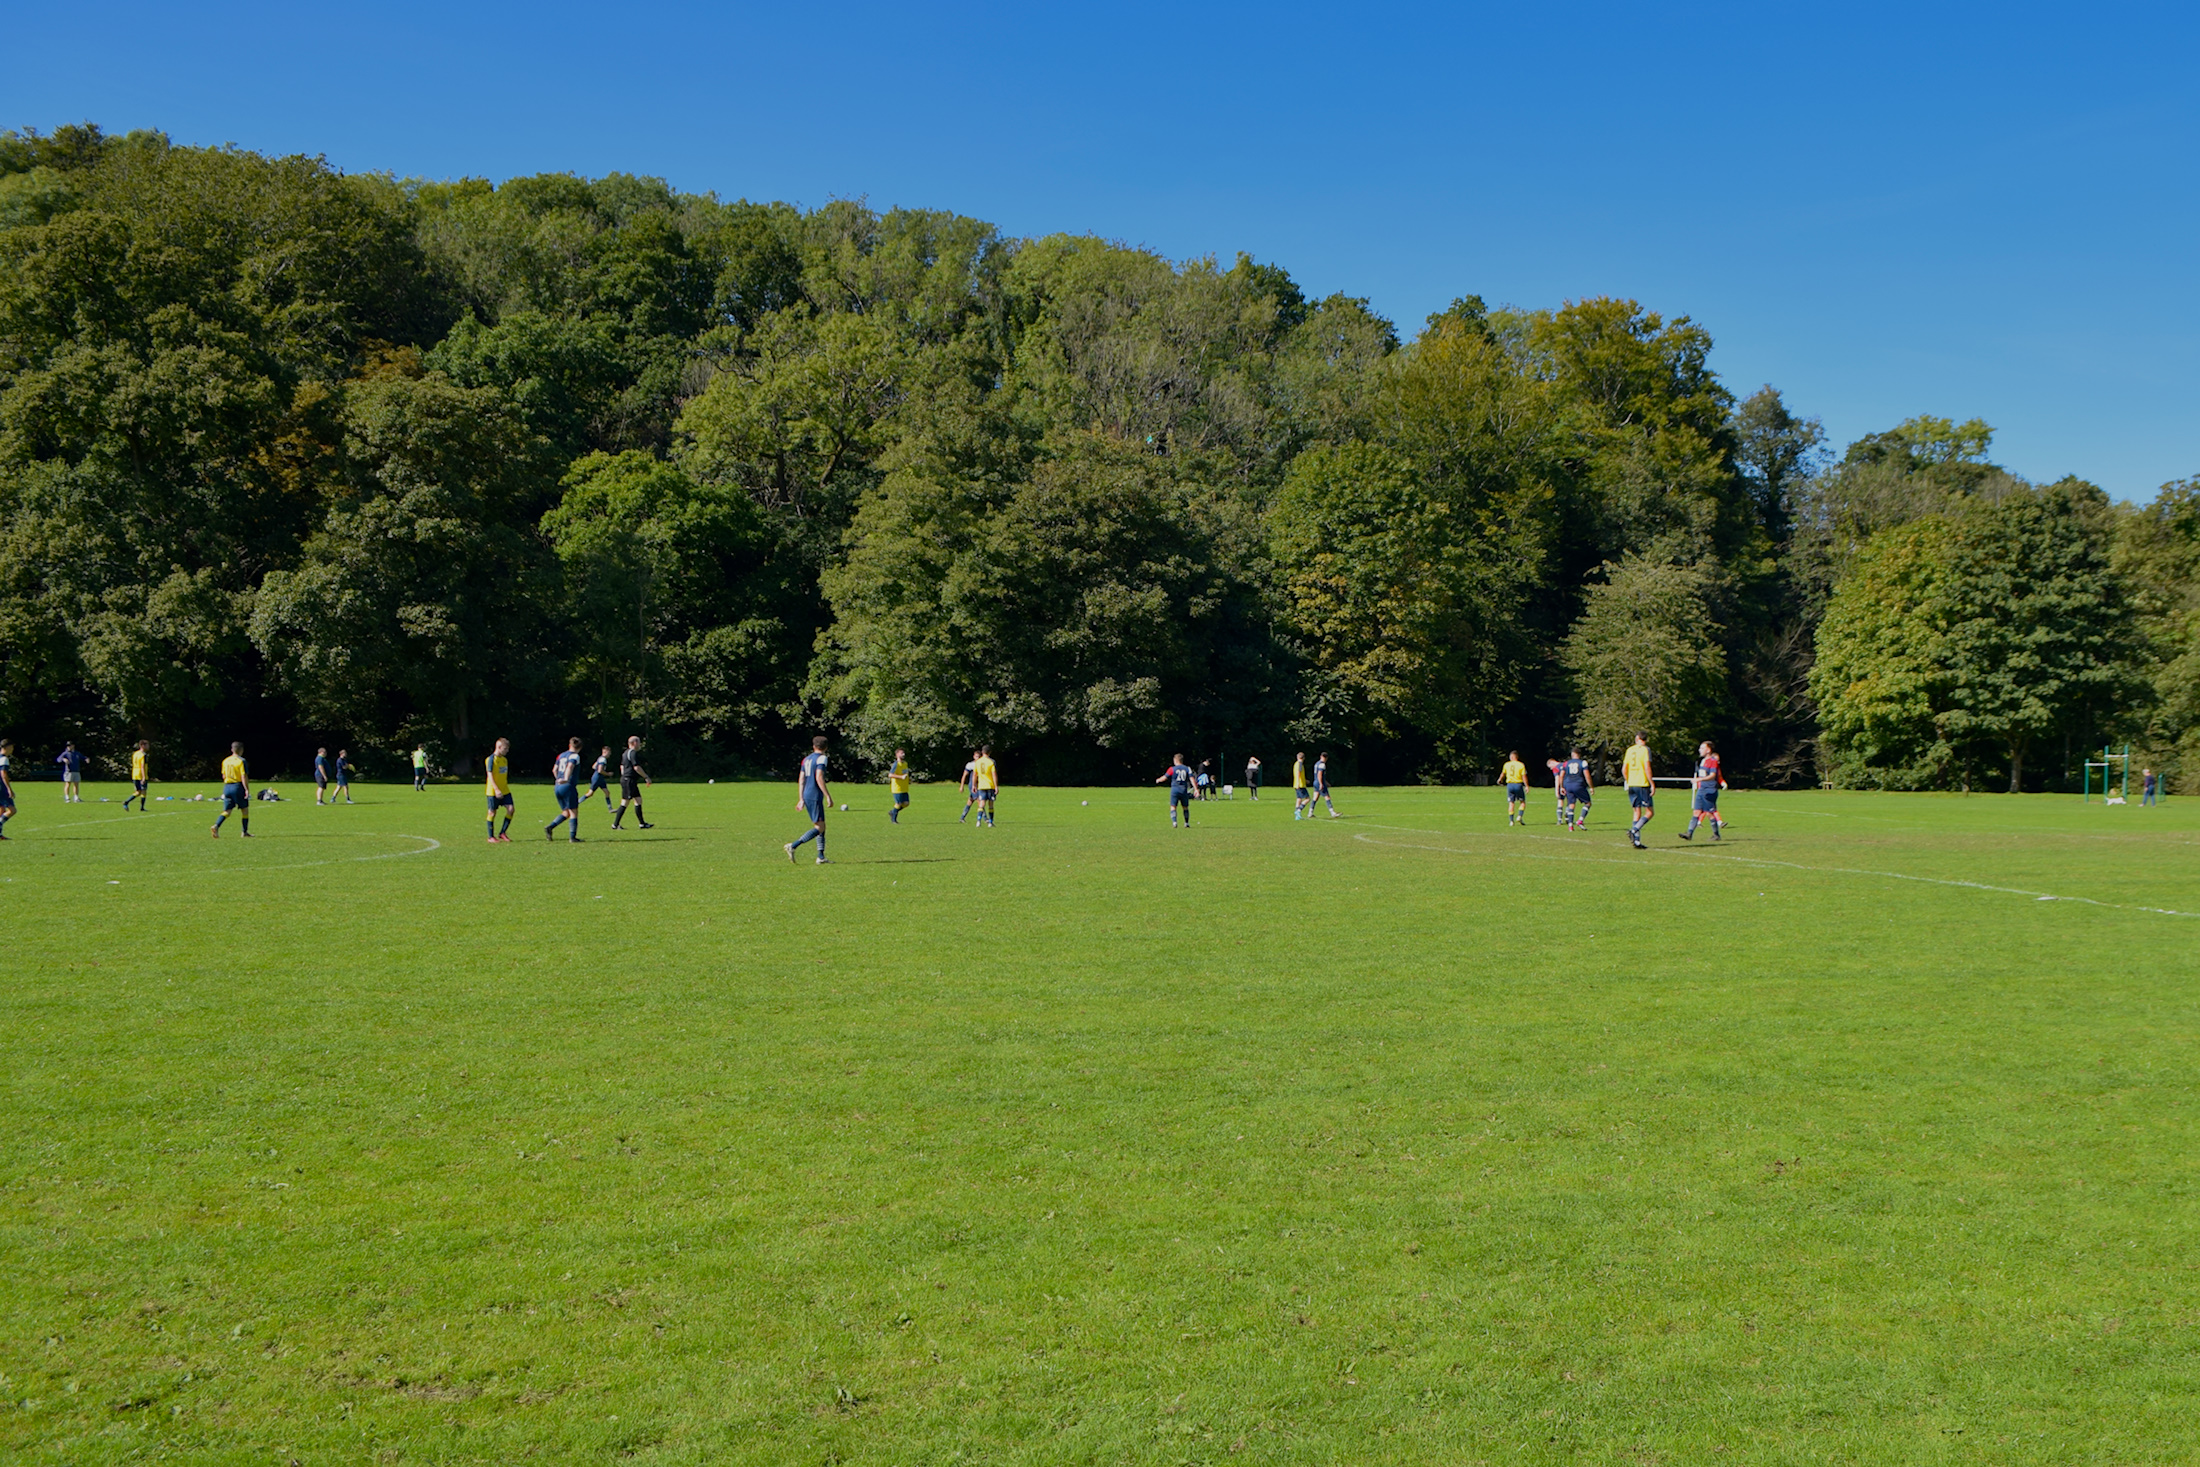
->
xmin=0 ymin=783 xmax=2200 ymax=1465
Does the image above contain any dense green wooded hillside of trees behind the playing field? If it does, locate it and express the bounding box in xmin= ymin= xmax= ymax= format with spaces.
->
xmin=0 ymin=125 xmax=2200 ymax=787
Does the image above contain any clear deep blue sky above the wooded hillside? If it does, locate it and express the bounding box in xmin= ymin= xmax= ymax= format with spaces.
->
xmin=0 ymin=0 xmax=2200 ymax=497
